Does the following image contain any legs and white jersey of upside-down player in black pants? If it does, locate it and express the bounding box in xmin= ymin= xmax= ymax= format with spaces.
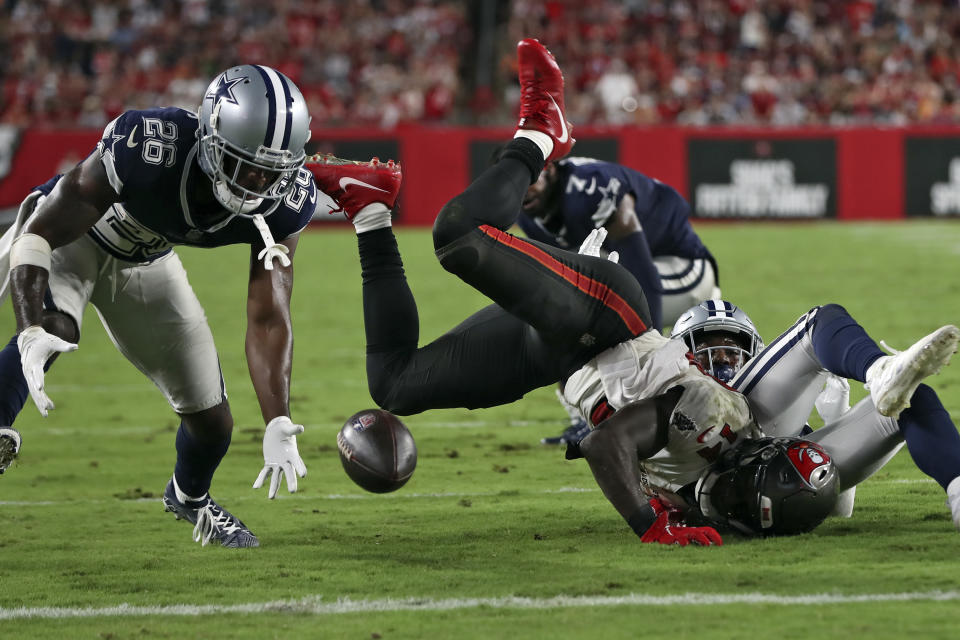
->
xmin=311 ymin=40 xmax=784 ymax=544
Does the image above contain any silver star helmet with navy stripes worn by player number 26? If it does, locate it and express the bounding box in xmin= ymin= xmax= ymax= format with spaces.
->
xmin=197 ymin=65 xmax=310 ymax=217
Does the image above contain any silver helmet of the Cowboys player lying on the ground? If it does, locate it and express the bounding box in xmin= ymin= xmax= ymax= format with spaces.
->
xmin=670 ymin=300 xmax=763 ymax=382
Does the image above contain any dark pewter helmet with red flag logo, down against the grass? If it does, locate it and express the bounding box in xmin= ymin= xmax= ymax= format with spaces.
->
xmin=695 ymin=438 xmax=839 ymax=536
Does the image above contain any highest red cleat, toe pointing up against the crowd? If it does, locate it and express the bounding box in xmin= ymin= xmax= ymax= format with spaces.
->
xmin=517 ymin=38 xmax=575 ymax=162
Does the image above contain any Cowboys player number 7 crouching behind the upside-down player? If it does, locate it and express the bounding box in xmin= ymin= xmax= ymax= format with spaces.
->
xmin=517 ymin=157 xmax=720 ymax=444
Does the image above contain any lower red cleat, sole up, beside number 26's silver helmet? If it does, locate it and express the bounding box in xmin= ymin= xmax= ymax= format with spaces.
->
xmin=305 ymin=153 xmax=403 ymax=220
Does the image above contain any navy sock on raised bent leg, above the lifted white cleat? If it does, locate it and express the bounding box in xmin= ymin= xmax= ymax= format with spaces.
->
xmin=812 ymin=304 xmax=885 ymax=382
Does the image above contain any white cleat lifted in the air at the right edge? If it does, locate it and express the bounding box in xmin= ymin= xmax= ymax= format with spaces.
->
xmin=865 ymin=324 xmax=960 ymax=418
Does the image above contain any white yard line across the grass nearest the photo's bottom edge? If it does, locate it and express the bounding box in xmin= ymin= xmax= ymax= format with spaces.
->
xmin=0 ymin=591 xmax=960 ymax=620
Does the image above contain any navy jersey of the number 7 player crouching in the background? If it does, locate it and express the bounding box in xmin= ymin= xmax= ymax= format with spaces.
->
xmin=519 ymin=157 xmax=710 ymax=258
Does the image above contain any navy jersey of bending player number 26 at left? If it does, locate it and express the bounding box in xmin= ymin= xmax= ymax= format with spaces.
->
xmin=37 ymin=107 xmax=318 ymax=262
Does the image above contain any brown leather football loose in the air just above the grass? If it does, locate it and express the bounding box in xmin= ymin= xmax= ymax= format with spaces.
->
xmin=337 ymin=409 xmax=417 ymax=493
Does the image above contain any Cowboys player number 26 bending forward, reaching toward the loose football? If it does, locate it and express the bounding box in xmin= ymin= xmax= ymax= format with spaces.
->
xmin=0 ymin=65 xmax=322 ymax=547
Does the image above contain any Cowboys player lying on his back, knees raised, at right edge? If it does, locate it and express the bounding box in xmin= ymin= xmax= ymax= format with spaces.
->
xmin=696 ymin=303 xmax=960 ymax=529
